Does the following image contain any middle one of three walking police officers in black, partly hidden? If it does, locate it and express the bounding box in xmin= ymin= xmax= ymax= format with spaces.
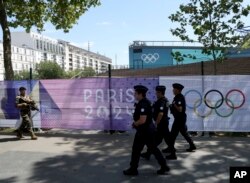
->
xmin=141 ymin=86 xmax=170 ymax=160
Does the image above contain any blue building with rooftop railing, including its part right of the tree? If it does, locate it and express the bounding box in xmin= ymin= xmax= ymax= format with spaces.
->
xmin=129 ymin=41 xmax=250 ymax=69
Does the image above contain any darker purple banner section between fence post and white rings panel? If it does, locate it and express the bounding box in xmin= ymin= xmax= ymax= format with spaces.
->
xmin=111 ymin=78 xmax=159 ymax=130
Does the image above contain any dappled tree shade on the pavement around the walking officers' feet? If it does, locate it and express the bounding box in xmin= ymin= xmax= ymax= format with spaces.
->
xmin=23 ymin=134 xmax=250 ymax=183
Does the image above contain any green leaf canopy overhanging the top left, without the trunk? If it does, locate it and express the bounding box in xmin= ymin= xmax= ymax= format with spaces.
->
xmin=5 ymin=0 xmax=100 ymax=32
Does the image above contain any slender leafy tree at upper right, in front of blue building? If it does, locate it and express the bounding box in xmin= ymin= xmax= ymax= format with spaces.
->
xmin=169 ymin=0 xmax=250 ymax=74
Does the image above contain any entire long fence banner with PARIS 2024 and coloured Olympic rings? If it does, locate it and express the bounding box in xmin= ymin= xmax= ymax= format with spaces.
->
xmin=0 ymin=75 xmax=250 ymax=132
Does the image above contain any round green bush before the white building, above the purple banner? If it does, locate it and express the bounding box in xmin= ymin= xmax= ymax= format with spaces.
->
xmin=36 ymin=61 xmax=64 ymax=79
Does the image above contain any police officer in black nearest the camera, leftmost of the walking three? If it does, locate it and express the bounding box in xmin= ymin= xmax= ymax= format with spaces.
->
xmin=123 ymin=85 xmax=170 ymax=176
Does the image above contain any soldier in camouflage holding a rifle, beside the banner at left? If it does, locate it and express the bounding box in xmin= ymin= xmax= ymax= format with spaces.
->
xmin=16 ymin=87 xmax=37 ymax=140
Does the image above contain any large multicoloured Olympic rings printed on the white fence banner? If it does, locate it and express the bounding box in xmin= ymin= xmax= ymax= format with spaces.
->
xmin=184 ymin=89 xmax=246 ymax=118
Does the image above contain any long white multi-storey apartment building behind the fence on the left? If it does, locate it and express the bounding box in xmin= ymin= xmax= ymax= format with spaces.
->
xmin=0 ymin=32 xmax=112 ymax=80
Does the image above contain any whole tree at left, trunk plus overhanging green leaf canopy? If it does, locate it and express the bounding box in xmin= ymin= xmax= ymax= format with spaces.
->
xmin=0 ymin=0 xmax=100 ymax=80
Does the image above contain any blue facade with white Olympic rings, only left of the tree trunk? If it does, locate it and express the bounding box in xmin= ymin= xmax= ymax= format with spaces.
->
xmin=129 ymin=41 xmax=215 ymax=69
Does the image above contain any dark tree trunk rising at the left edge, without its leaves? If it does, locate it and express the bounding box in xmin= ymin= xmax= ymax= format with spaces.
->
xmin=0 ymin=0 xmax=14 ymax=80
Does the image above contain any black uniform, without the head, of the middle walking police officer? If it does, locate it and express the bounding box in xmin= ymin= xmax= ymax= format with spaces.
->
xmin=141 ymin=94 xmax=170 ymax=159
